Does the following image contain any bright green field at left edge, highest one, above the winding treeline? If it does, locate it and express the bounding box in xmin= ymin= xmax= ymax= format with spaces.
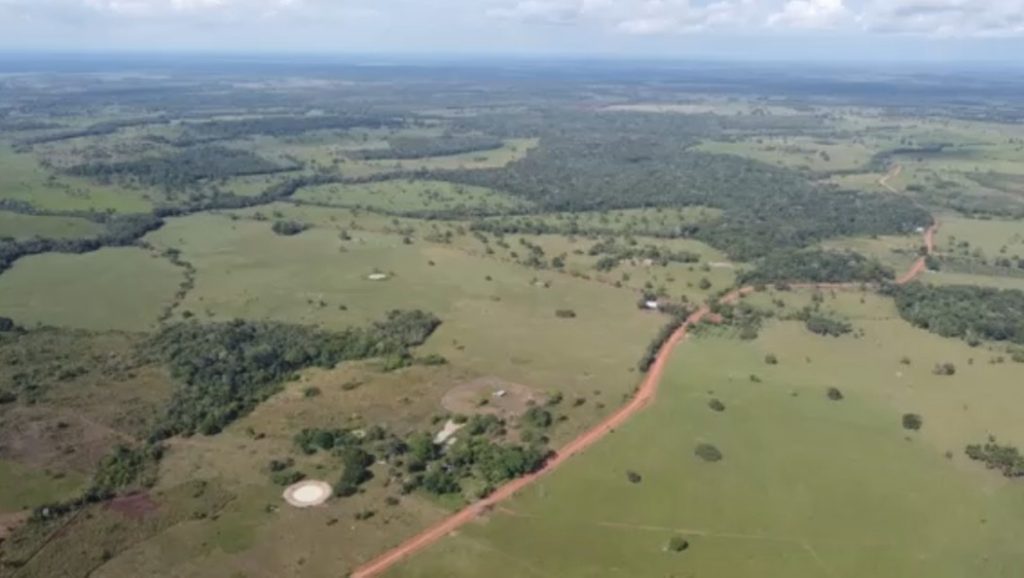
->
xmin=0 ymin=143 xmax=153 ymax=213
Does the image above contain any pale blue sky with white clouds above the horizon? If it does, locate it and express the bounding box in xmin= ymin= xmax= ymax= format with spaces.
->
xmin=0 ymin=0 xmax=1024 ymax=61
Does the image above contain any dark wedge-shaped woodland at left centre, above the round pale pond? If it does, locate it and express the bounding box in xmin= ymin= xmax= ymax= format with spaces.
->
xmin=151 ymin=311 xmax=440 ymax=440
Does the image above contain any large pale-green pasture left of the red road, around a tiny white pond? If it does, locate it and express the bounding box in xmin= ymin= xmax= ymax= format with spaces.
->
xmin=146 ymin=215 xmax=666 ymax=422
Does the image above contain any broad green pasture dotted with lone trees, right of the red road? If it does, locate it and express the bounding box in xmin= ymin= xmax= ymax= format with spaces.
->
xmin=389 ymin=294 xmax=1024 ymax=578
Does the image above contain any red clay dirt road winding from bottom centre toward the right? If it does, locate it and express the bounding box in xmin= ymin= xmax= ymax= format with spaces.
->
xmin=351 ymin=219 xmax=938 ymax=578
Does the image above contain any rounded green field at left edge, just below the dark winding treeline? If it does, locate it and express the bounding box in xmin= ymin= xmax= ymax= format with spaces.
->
xmin=0 ymin=248 xmax=182 ymax=331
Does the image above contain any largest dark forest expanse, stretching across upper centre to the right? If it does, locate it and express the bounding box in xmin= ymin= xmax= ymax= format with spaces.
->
xmin=432 ymin=137 xmax=932 ymax=260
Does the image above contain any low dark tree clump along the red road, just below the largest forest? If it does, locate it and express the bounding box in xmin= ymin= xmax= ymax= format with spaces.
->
xmin=737 ymin=249 xmax=895 ymax=285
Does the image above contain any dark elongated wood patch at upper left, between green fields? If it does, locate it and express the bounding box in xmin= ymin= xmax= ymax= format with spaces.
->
xmin=67 ymin=147 xmax=297 ymax=191
